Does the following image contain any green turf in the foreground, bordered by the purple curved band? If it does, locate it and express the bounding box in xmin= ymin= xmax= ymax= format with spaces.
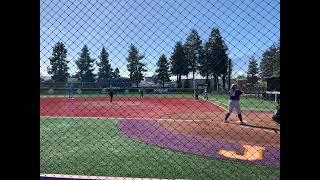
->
xmin=40 ymin=119 xmax=280 ymax=179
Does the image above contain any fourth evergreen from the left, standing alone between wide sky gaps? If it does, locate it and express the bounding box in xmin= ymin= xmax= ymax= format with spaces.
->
xmin=127 ymin=44 xmax=147 ymax=87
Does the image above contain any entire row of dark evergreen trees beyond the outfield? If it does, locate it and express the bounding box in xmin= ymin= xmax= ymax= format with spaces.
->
xmin=48 ymin=28 xmax=280 ymax=90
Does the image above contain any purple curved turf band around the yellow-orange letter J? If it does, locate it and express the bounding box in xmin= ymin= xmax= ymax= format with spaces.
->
xmin=117 ymin=119 xmax=280 ymax=165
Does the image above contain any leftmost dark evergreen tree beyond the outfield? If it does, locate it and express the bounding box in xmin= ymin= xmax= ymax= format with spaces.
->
xmin=48 ymin=42 xmax=69 ymax=82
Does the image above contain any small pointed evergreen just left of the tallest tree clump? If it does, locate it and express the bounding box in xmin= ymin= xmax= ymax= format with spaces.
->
xmin=156 ymin=54 xmax=170 ymax=87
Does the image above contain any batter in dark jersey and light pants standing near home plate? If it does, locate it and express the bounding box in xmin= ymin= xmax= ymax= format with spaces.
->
xmin=224 ymin=84 xmax=244 ymax=124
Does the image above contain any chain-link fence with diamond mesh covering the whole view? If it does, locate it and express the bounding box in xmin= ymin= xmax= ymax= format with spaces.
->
xmin=40 ymin=0 xmax=280 ymax=179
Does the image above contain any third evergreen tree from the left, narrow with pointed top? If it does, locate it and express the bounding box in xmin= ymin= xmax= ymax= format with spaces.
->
xmin=97 ymin=47 xmax=113 ymax=79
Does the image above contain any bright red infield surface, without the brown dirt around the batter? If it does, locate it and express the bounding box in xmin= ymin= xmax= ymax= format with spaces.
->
xmin=40 ymin=97 xmax=224 ymax=119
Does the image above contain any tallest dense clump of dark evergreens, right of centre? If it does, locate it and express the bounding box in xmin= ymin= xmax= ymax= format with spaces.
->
xmin=170 ymin=28 xmax=232 ymax=89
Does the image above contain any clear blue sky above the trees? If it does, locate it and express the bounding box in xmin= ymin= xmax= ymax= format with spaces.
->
xmin=40 ymin=0 xmax=280 ymax=79
